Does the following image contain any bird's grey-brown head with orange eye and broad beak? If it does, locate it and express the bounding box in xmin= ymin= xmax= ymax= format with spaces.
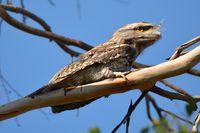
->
xmin=110 ymin=22 xmax=161 ymax=54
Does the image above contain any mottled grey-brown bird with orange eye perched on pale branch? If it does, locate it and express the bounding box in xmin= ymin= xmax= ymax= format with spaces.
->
xmin=28 ymin=22 xmax=161 ymax=113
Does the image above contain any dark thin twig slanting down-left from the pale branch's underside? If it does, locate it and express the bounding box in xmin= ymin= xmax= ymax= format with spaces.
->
xmin=111 ymin=91 xmax=148 ymax=133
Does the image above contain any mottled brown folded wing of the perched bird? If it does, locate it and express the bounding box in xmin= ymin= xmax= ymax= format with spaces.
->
xmin=49 ymin=43 xmax=135 ymax=83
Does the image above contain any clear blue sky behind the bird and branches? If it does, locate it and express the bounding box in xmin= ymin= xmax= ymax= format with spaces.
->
xmin=0 ymin=0 xmax=200 ymax=133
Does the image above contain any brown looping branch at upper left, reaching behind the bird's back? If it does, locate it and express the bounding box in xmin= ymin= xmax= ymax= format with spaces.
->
xmin=0 ymin=5 xmax=92 ymax=55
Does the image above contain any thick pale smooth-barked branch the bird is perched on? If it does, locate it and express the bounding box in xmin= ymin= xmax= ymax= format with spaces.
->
xmin=0 ymin=46 xmax=200 ymax=120
